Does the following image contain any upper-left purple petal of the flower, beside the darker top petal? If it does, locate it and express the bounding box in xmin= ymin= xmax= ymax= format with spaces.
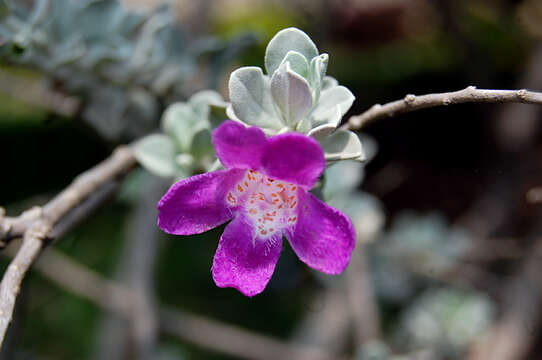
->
xmin=213 ymin=120 xmax=267 ymax=169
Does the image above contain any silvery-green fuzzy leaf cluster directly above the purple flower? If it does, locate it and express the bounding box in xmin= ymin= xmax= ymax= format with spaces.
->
xmin=227 ymin=28 xmax=365 ymax=161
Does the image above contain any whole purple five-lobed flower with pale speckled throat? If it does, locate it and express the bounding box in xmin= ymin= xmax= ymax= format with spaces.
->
xmin=158 ymin=121 xmax=355 ymax=296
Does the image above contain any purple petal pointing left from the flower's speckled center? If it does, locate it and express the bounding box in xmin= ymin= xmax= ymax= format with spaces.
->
xmin=158 ymin=169 xmax=245 ymax=235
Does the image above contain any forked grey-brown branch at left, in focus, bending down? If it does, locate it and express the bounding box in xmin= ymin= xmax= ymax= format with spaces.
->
xmin=0 ymin=146 xmax=136 ymax=346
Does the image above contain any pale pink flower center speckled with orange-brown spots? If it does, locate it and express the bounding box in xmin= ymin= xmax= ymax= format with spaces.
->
xmin=226 ymin=170 xmax=298 ymax=238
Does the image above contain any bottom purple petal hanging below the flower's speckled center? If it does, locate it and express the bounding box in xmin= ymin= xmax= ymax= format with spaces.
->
xmin=212 ymin=216 xmax=282 ymax=296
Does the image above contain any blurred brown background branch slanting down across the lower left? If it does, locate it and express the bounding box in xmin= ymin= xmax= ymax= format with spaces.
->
xmin=2 ymin=247 xmax=343 ymax=360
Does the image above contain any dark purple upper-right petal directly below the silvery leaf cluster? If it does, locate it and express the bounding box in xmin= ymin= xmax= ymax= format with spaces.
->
xmin=262 ymin=133 xmax=326 ymax=188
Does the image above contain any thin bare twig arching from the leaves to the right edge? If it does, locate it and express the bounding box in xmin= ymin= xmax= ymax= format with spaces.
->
xmin=345 ymin=86 xmax=542 ymax=130
